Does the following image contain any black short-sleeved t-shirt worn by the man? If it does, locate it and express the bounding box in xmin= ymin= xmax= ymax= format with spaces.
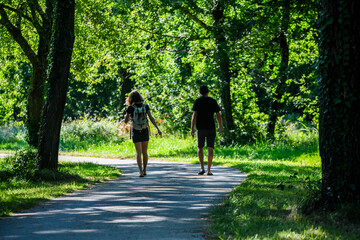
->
xmin=193 ymin=97 xmax=220 ymax=130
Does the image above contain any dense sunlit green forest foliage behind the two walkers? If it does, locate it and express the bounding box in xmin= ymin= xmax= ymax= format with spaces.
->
xmin=0 ymin=0 xmax=318 ymax=144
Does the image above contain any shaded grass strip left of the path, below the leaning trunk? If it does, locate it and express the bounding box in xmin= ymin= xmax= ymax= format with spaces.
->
xmin=0 ymin=159 xmax=121 ymax=216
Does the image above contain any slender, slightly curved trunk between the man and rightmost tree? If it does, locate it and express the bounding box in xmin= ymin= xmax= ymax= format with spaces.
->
xmin=267 ymin=0 xmax=290 ymax=139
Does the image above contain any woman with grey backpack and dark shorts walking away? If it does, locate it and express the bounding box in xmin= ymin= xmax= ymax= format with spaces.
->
xmin=125 ymin=90 xmax=162 ymax=177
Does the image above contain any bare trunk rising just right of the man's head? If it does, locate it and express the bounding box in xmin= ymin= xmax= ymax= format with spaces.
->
xmin=212 ymin=0 xmax=235 ymax=135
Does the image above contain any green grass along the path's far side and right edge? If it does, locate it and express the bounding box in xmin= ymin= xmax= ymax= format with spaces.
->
xmin=0 ymin=121 xmax=360 ymax=239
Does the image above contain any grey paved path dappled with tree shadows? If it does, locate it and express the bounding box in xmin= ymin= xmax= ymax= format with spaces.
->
xmin=0 ymin=157 xmax=246 ymax=240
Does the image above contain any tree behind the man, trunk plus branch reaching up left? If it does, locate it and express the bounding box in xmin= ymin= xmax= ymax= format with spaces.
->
xmin=172 ymin=0 xmax=246 ymax=140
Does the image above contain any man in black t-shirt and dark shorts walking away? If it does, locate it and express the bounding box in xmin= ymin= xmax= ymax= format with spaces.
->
xmin=191 ymin=86 xmax=222 ymax=175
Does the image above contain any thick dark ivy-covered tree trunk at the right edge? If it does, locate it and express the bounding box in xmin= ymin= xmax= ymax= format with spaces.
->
xmin=319 ymin=0 xmax=360 ymax=208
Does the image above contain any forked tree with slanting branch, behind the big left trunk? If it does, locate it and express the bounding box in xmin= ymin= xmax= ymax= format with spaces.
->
xmin=0 ymin=0 xmax=54 ymax=147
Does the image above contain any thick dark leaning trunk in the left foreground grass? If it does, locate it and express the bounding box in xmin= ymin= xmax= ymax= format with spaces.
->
xmin=38 ymin=0 xmax=75 ymax=169
